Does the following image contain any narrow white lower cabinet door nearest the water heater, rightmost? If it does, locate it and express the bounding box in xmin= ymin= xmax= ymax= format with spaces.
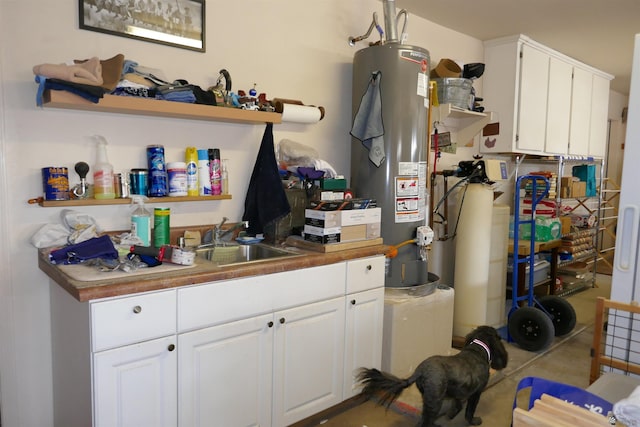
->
xmin=343 ymin=288 xmax=384 ymax=400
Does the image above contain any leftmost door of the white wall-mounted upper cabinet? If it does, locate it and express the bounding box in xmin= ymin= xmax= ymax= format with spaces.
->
xmin=516 ymin=44 xmax=549 ymax=152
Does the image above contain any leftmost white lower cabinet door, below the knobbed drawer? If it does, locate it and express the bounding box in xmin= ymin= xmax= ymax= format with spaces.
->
xmin=93 ymin=335 xmax=178 ymax=427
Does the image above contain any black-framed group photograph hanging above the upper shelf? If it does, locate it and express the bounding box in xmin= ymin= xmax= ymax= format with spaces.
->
xmin=78 ymin=0 xmax=205 ymax=52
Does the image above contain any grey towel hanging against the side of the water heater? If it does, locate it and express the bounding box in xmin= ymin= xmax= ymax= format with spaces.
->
xmin=351 ymin=71 xmax=386 ymax=167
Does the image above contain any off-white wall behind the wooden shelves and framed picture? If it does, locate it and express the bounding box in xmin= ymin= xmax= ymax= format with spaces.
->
xmin=0 ymin=0 xmax=482 ymax=427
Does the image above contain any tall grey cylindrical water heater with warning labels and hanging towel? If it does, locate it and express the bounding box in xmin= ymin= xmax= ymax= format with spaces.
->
xmin=349 ymin=1 xmax=433 ymax=288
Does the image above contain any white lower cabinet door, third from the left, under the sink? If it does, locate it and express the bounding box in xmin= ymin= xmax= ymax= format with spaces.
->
xmin=272 ymin=297 xmax=344 ymax=427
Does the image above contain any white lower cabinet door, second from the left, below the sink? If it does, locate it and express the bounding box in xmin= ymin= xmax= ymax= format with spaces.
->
xmin=178 ymin=314 xmax=274 ymax=427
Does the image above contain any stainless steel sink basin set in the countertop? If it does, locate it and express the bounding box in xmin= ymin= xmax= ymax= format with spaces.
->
xmin=196 ymin=243 xmax=300 ymax=265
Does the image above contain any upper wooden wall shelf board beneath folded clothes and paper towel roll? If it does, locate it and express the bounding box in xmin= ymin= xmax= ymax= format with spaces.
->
xmin=43 ymin=90 xmax=282 ymax=124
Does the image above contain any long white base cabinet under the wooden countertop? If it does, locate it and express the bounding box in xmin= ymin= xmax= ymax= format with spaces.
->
xmin=51 ymin=255 xmax=384 ymax=427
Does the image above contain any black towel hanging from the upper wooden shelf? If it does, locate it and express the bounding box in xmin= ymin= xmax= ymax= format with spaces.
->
xmin=242 ymin=123 xmax=291 ymax=236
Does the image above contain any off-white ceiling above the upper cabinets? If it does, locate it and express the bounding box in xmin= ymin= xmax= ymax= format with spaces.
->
xmin=395 ymin=0 xmax=640 ymax=95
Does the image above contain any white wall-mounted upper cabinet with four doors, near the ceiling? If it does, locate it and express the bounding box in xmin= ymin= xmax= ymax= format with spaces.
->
xmin=480 ymin=36 xmax=613 ymax=156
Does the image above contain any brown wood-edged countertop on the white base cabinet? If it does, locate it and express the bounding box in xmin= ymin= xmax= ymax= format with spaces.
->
xmin=38 ymin=244 xmax=388 ymax=302
